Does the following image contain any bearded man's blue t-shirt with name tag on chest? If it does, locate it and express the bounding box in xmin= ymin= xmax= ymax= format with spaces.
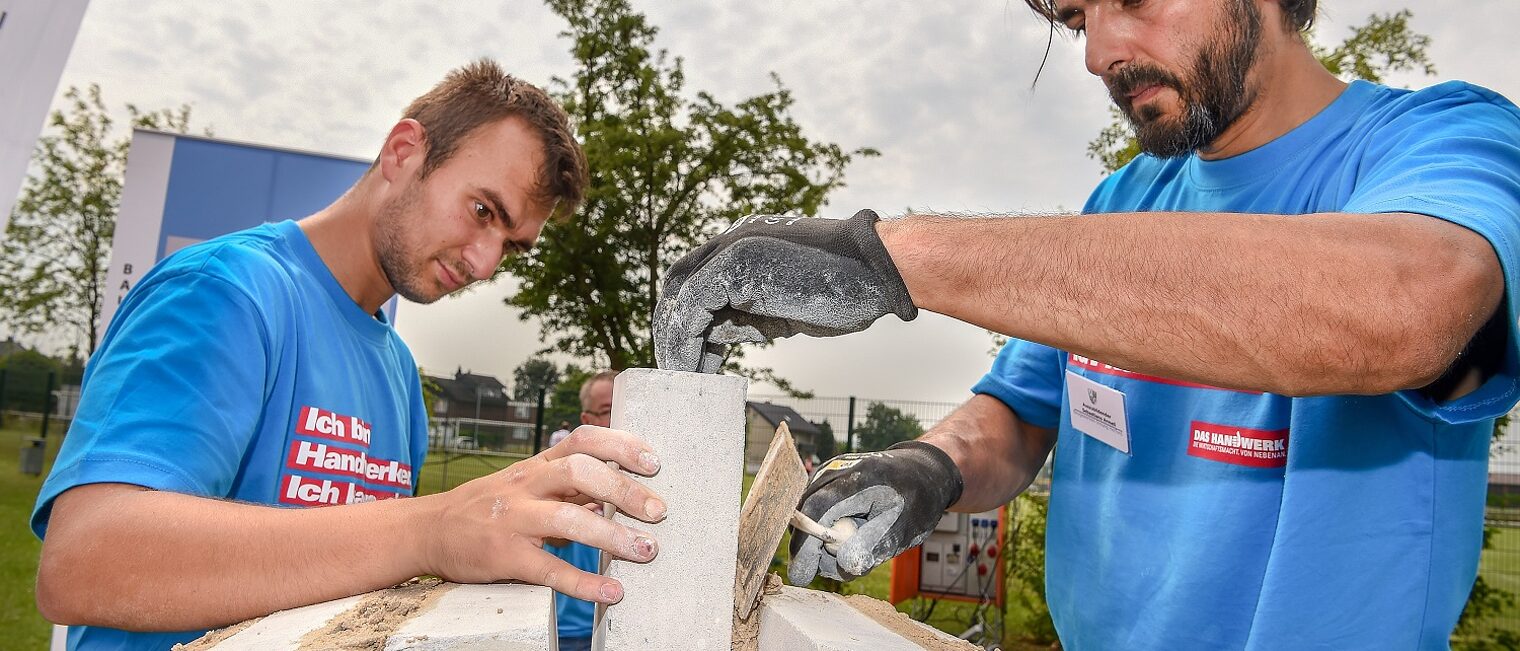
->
xmin=973 ymin=82 xmax=1520 ymax=651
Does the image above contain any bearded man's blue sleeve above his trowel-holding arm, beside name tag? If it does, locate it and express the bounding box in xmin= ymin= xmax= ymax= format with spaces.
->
xmin=971 ymin=339 xmax=1066 ymax=429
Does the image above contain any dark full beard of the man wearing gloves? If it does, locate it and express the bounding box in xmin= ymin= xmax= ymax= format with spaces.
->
xmin=1108 ymin=0 xmax=1262 ymax=158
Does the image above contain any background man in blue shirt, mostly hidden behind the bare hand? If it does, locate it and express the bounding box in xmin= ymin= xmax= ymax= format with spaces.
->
xmin=544 ymin=371 xmax=617 ymax=651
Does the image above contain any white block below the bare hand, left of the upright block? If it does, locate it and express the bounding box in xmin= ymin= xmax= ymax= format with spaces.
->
xmin=385 ymin=584 xmax=559 ymax=651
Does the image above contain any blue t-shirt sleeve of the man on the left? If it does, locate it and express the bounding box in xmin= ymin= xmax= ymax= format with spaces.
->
xmin=32 ymin=271 xmax=269 ymax=537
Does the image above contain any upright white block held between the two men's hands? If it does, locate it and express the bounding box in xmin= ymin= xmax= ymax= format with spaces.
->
xmin=591 ymin=368 xmax=748 ymax=651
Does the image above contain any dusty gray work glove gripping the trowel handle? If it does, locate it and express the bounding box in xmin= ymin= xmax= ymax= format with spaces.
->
xmin=786 ymin=441 xmax=964 ymax=586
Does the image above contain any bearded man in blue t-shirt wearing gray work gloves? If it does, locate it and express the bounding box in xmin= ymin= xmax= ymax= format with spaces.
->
xmin=654 ymin=0 xmax=1520 ymax=651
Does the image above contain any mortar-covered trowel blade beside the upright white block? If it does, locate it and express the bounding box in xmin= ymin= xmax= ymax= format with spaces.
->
xmin=734 ymin=423 xmax=807 ymax=621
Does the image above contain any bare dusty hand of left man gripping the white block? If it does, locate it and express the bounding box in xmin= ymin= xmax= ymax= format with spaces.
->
xmin=423 ymin=424 xmax=666 ymax=604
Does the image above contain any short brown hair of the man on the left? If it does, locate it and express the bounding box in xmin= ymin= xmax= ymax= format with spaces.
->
xmin=401 ymin=59 xmax=587 ymax=219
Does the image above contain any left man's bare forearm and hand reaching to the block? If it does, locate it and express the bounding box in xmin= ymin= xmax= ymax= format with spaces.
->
xmin=36 ymin=426 xmax=666 ymax=631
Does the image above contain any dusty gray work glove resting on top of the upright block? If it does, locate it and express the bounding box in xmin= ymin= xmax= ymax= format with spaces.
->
xmin=654 ymin=210 xmax=918 ymax=373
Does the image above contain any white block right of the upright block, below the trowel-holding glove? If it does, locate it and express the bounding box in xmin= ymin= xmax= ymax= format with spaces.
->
xmin=760 ymin=586 xmax=974 ymax=651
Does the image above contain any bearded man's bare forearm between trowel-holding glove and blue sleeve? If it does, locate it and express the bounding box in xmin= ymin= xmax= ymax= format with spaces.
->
xmin=923 ymin=395 xmax=1055 ymax=513
